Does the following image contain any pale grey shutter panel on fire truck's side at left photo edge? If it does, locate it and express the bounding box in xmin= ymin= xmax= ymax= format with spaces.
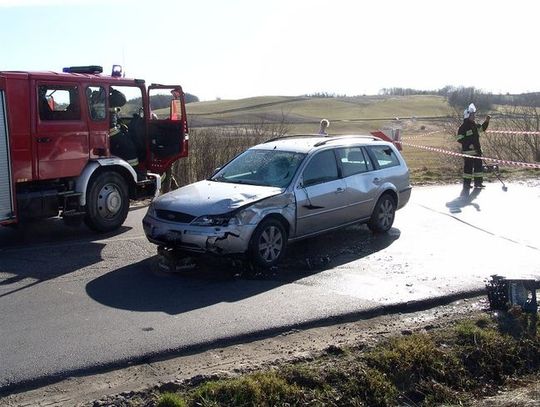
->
xmin=0 ymin=90 xmax=14 ymax=222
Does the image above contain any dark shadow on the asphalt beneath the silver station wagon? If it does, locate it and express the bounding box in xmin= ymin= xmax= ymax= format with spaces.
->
xmin=86 ymin=226 xmax=400 ymax=315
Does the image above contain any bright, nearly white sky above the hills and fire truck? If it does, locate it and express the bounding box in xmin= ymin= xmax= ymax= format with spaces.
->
xmin=0 ymin=0 xmax=540 ymax=100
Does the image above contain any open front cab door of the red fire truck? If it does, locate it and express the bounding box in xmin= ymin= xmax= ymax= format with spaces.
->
xmin=146 ymin=85 xmax=189 ymax=174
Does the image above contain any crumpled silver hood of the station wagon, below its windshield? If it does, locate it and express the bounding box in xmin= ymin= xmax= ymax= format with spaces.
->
xmin=154 ymin=181 xmax=283 ymax=216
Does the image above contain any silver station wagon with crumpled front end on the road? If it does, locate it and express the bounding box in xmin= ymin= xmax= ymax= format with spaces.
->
xmin=143 ymin=135 xmax=411 ymax=268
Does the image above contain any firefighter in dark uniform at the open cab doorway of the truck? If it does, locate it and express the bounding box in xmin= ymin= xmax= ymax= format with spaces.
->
xmin=109 ymin=88 xmax=139 ymax=169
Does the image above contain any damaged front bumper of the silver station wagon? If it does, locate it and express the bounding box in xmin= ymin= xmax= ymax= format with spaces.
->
xmin=143 ymin=214 xmax=257 ymax=254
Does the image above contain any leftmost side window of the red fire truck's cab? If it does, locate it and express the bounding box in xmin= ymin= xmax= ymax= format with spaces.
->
xmin=38 ymin=85 xmax=81 ymax=121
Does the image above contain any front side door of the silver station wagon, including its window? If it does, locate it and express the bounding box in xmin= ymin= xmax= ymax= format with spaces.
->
xmin=295 ymin=150 xmax=347 ymax=237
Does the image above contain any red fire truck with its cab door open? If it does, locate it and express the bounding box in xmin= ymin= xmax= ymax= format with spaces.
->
xmin=0 ymin=65 xmax=189 ymax=232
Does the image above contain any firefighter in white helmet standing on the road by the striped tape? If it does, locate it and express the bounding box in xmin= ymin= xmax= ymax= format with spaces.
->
xmin=457 ymin=103 xmax=490 ymax=189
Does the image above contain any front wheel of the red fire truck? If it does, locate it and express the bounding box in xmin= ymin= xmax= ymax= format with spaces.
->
xmin=84 ymin=172 xmax=129 ymax=232
